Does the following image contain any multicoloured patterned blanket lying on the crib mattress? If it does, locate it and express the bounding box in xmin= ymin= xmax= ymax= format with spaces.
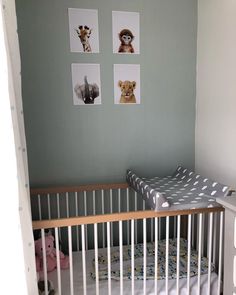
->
xmin=91 ymin=238 xmax=215 ymax=280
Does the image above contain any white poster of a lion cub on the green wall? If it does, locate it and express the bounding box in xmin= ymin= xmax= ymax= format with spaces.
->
xmin=114 ymin=64 xmax=140 ymax=105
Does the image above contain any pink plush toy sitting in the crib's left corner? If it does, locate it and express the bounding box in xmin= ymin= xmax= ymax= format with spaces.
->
xmin=35 ymin=235 xmax=69 ymax=272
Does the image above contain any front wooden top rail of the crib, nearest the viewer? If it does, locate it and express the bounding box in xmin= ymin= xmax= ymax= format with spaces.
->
xmin=33 ymin=207 xmax=224 ymax=229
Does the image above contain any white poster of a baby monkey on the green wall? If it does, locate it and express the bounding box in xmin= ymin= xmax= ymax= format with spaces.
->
xmin=112 ymin=11 xmax=140 ymax=54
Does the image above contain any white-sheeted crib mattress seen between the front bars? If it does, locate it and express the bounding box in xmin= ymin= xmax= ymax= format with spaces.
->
xmin=48 ymin=247 xmax=218 ymax=295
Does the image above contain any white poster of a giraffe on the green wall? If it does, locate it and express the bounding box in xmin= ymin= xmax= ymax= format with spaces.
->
xmin=68 ymin=8 xmax=99 ymax=53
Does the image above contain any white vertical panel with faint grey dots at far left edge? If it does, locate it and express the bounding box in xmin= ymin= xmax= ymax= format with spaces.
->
xmin=0 ymin=0 xmax=38 ymax=295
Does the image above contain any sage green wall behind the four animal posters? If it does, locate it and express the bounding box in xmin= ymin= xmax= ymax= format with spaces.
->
xmin=16 ymin=0 xmax=197 ymax=186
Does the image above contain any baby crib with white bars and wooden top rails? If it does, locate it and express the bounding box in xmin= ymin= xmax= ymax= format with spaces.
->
xmin=31 ymin=183 xmax=224 ymax=295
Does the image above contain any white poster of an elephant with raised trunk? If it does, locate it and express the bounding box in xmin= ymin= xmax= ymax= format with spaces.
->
xmin=71 ymin=64 xmax=101 ymax=105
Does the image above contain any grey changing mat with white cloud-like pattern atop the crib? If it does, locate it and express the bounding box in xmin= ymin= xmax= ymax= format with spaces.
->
xmin=126 ymin=166 xmax=230 ymax=211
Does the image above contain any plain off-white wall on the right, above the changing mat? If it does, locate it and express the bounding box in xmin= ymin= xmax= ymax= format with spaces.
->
xmin=195 ymin=0 xmax=236 ymax=187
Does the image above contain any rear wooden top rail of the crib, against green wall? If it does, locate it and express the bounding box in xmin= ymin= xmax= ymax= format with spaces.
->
xmin=30 ymin=183 xmax=129 ymax=196
